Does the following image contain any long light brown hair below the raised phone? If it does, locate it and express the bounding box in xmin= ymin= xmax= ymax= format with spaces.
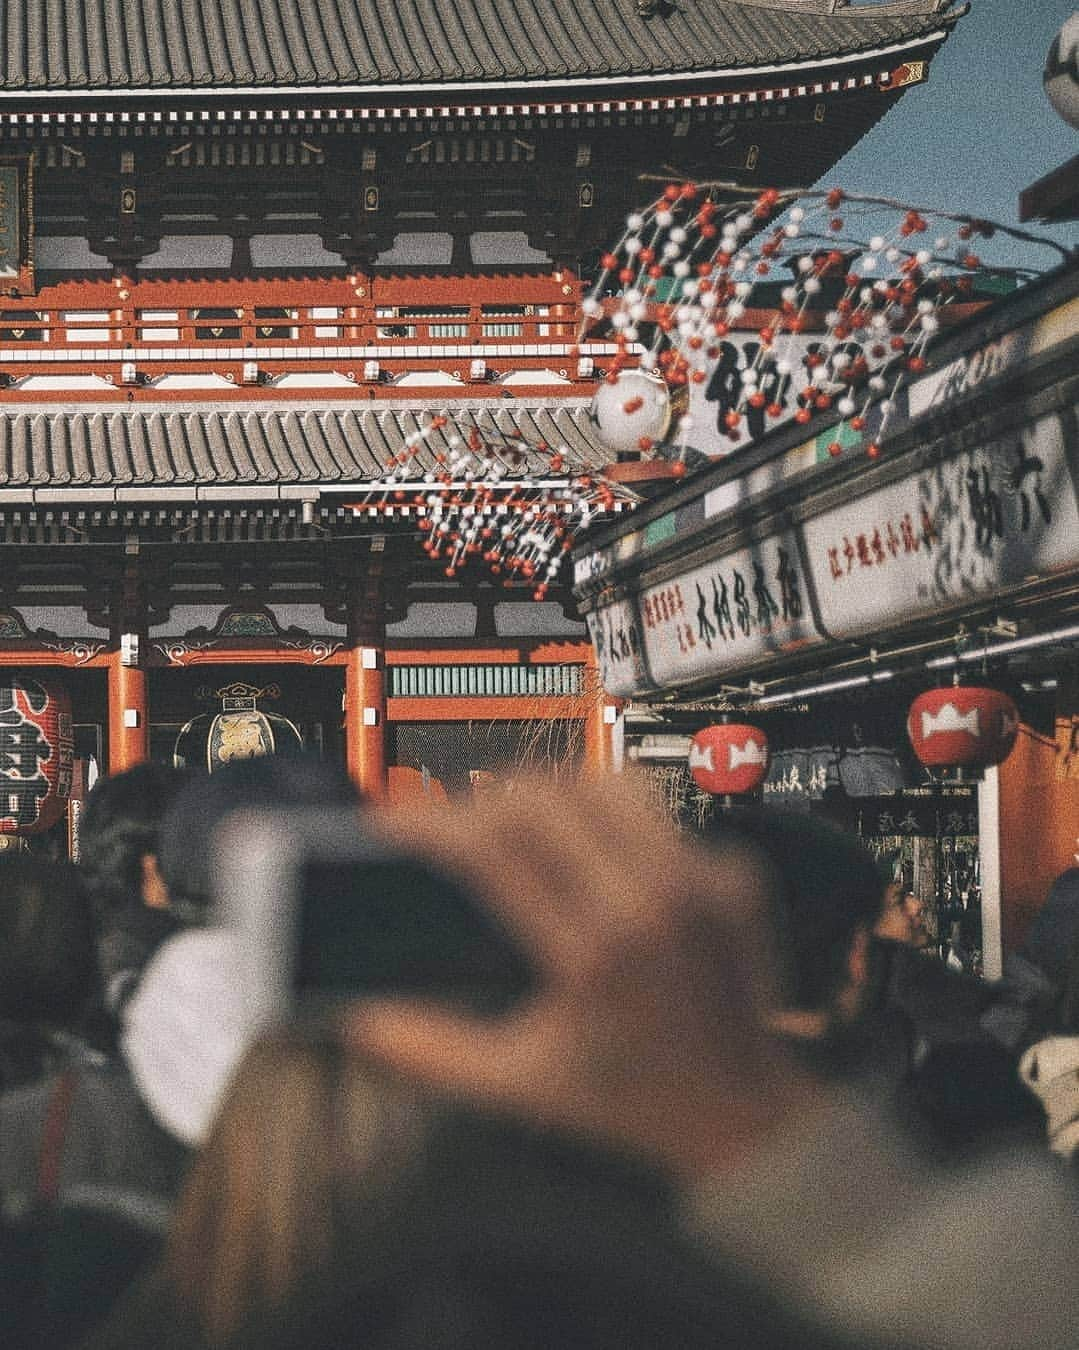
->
xmin=162 ymin=1030 xmax=428 ymax=1345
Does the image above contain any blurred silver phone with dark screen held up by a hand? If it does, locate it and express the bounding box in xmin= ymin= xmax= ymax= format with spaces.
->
xmin=215 ymin=807 xmax=533 ymax=1018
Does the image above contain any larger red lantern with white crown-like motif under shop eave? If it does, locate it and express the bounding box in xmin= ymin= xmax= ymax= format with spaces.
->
xmin=906 ymin=684 xmax=1020 ymax=768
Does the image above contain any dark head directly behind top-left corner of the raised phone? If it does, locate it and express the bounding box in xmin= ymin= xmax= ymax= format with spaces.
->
xmin=161 ymin=755 xmax=359 ymax=909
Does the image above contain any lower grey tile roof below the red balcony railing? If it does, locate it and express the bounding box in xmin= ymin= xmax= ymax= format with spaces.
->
xmin=0 ymin=401 xmax=610 ymax=496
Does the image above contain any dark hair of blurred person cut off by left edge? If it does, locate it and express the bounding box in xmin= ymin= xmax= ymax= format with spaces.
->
xmin=0 ymin=853 xmax=97 ymax=1026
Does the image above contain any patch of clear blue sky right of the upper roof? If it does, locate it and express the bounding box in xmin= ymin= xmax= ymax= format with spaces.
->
xmin=821 ymin=0 xmax=1079 ymax=269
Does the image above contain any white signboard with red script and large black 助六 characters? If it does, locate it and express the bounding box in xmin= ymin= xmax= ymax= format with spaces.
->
xmin=802 ymin=416 xmax=1079 ymax=637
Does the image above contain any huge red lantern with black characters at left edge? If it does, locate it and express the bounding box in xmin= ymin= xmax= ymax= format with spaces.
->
xmin=0 ymin=674 xmax=74 ymax=834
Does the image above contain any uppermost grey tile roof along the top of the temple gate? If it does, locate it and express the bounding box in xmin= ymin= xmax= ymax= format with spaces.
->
xmin=0 ymin=0 xmax=956 ymax=97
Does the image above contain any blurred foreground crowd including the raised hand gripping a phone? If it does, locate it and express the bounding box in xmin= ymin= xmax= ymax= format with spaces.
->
xmin=0 ymin=759 xmax=1079 ymax=1350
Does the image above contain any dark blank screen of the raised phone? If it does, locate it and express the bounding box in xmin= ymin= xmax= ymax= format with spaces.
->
xmin=293 ymin=857 xmax=531 ymax=1013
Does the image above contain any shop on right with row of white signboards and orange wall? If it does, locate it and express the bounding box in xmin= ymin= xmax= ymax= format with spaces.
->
xmin=574 ymin=257 xmax=1079 ymax=975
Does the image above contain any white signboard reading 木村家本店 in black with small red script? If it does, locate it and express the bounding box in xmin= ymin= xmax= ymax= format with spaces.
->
xmin=637 ymin=535 xmax=820 ymax=687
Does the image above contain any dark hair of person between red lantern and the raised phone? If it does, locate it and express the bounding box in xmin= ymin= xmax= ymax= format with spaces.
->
xmin=78 ymin=763 xmax=188 ymax=915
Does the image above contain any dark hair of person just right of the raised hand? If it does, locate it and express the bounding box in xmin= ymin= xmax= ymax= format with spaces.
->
xmin=708 ymin=807 xmax=885 ymax=1011
